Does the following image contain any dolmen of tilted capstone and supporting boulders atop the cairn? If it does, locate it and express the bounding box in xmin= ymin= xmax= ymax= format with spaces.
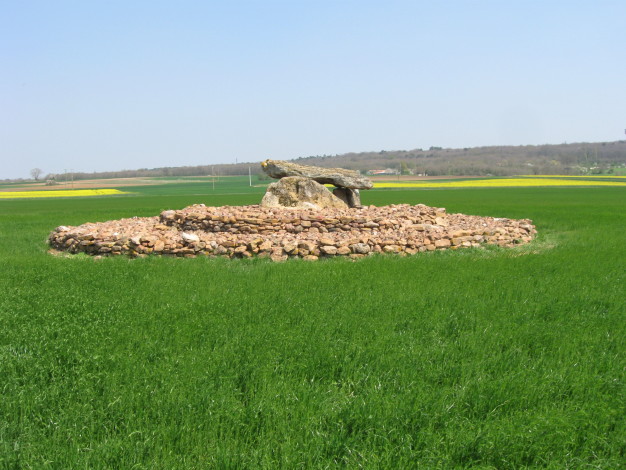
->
xmin=261 ymin=160 xmax=374 ymax=209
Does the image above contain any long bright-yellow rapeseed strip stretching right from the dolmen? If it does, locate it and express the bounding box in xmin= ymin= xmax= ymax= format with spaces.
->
xmin=374 ymin=178 xmax=626 ymax=188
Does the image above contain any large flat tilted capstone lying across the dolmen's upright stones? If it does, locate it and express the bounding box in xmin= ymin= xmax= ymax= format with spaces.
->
xmin=261 ymin=160 xmax=374 ymax=189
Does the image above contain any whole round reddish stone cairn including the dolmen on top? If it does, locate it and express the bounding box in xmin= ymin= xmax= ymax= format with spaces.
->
xmin=48 ymin=160 xmax=536 ymax=261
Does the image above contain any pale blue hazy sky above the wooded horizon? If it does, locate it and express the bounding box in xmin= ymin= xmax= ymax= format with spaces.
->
xmin=0 ymin=0 xmax=626 ymax=179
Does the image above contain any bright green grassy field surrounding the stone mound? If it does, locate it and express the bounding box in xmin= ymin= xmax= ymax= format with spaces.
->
xmin=0 ymin=180 xmax=626 ymax=469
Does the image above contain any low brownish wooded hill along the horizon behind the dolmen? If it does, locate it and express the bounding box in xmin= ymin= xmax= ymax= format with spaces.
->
xmin=48 ymin=140 xmax=626 ymax=180
